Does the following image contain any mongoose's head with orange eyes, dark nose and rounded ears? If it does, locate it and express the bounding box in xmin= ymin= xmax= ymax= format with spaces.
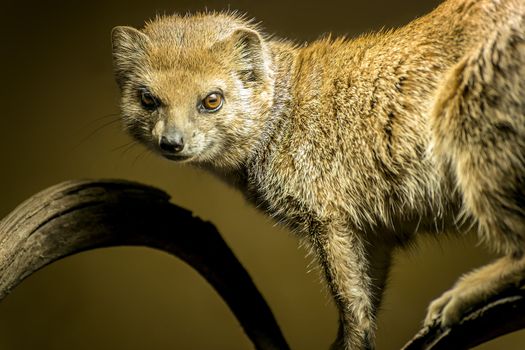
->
xmin=112 ymin=13 xmax=273 ymax=167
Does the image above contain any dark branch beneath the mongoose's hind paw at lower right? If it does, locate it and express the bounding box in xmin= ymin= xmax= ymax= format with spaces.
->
xmin=402 ymin=289 xmax=525 ymax=350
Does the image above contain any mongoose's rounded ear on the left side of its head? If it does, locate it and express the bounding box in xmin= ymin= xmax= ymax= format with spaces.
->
xmin=111 ymin=26 xmax=149 ymax=86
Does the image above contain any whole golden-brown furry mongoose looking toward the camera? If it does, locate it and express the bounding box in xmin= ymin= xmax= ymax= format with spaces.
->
xmin=112 ymin=0 xmax=525 ymax=349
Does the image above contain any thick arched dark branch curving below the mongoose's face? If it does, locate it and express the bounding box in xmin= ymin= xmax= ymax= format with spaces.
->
xmin=0 ymin=181 xmax=289 ymax=349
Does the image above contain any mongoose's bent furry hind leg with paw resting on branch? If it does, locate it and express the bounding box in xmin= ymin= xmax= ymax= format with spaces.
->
xmin=425 ymin=10 xmax=525 ymax=326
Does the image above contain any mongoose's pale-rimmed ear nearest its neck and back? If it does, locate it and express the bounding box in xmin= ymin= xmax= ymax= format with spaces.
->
xmin=229 ymin=28 xmax=269 ymax=83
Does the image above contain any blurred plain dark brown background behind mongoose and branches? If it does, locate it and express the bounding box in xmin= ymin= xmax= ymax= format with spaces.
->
xmin=0 ymin=0 xmax=525 ymax=350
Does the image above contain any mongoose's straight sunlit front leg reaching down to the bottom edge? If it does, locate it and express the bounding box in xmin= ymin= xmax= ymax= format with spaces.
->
xmin=312 ymin=223 xmax=390 ymax=350
